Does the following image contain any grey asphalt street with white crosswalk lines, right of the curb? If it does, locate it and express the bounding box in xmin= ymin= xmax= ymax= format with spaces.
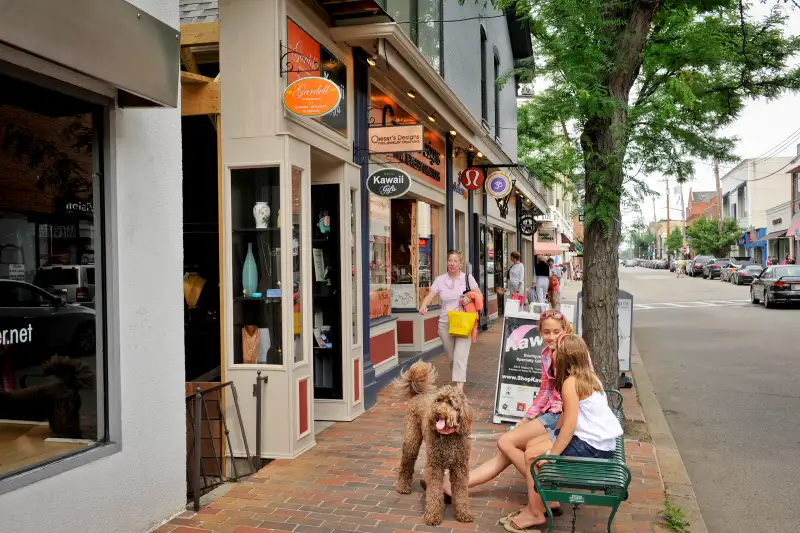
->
xmin=620 ymin=267 xmax=800 ymax=533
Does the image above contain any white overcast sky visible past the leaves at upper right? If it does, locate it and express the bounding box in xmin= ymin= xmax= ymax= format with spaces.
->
xmin=624 ymin=2 xmax=800 ymax=223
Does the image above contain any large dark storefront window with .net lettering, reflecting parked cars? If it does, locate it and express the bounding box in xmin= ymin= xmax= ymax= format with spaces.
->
xmin=0 ymin=71 xmax=107 ymax=479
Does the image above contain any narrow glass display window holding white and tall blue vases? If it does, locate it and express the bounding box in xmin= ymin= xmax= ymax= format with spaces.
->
xmin=231 ymin=167 xmax=282 ymax=365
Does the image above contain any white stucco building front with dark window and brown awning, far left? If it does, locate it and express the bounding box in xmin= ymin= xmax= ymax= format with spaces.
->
xmin=0 ymin=0 xmax=186 ymax=533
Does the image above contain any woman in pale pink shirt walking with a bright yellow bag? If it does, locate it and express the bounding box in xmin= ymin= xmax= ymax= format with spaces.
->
xmin=419 ymin=250 xmax=483 ymax=392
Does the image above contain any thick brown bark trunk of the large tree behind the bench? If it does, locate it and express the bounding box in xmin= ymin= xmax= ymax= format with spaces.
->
xmin=581 ymin=0 xmax=661 ymax=388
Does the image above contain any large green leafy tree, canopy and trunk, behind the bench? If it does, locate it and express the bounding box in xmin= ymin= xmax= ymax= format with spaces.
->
xmin=494 ymin=0 xmax=800 ymax=385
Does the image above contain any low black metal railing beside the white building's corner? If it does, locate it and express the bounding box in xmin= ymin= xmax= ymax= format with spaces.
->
xmin=186 ymin=381 xmax=255 ymax=511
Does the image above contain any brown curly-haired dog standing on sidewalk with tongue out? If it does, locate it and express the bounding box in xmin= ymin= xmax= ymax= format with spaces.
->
xmin=395 ymin=361 xmax=472 ymax=526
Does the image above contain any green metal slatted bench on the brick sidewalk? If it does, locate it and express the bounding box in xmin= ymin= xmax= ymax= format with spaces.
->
xmin=531 ymin=389 xmax=631 ymax=533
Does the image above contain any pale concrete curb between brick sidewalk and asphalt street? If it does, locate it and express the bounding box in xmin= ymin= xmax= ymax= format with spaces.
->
xmin=631 ymin=338 xmax=708 ymax=533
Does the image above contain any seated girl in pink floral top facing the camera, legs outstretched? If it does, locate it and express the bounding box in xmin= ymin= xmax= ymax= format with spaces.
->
xmin=444 ymin=310 xmax=573 ymax=502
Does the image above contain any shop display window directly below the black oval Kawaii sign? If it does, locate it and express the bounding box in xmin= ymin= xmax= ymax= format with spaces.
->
xmin=370 ymin=195 xmax=439 ymax=312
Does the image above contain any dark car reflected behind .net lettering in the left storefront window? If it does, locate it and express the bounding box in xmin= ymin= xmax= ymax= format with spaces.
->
xmin=0 ymin=279 xmax=96 ymax=368
